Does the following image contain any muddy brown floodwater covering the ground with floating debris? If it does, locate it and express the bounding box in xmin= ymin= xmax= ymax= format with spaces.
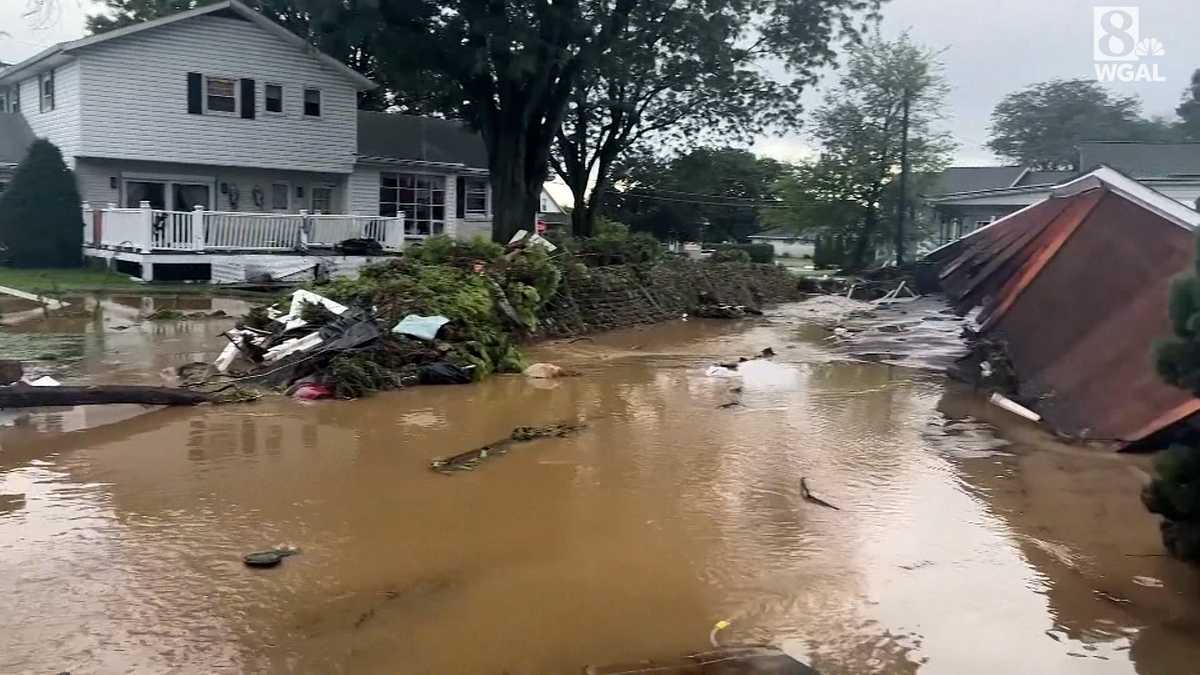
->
xmin=0 ymin=296 xmax=1200 ymax=675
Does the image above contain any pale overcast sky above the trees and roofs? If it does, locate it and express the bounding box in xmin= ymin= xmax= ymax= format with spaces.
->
xmin=0 ymin=0 xmax=1200 ymax=165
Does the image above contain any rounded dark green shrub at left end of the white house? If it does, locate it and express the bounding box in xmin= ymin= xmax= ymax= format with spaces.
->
xmin=0 ymin=139 xmax=84 ymax=268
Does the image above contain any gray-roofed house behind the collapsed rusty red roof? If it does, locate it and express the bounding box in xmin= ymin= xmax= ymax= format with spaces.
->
xmin=922 ymin=142 xmax=1200 ymax=243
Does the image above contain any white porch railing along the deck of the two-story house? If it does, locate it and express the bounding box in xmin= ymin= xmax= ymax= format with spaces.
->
xmin=83 ymin=202 xmax=413 ymax=253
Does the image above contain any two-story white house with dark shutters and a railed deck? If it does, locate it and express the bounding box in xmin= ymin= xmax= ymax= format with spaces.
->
xmin=0 ymin=0 xmax=491 ymax=281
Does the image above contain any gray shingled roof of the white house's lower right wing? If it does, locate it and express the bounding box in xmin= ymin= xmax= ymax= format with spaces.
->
xmin=359 ymin=110 xmax=487 ymax=169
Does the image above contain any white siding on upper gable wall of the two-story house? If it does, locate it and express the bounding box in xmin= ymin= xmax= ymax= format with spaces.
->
xmin=73 ymin=16 xmax=358 ymax=174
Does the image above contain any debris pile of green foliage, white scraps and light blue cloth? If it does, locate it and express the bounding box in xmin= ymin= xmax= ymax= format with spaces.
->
xmin=187 ymin=237 xmax=559 ymax=400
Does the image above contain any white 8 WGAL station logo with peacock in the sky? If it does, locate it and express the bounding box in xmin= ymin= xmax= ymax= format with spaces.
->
xmin=1092 ymin=7 xmax=1166 ymax=82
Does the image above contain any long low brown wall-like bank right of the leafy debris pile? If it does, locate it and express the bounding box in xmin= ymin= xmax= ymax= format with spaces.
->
xmin=540 ymin=258 xmax=802 ymax=336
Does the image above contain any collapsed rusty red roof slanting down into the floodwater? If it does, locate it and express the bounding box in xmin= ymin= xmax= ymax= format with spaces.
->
xmin=930 ymin=169 xmax=1200 ymax=442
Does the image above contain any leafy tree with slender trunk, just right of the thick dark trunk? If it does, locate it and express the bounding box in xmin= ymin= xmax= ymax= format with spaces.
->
xmin=553 ymin=0 xmax=878 ymax=235
